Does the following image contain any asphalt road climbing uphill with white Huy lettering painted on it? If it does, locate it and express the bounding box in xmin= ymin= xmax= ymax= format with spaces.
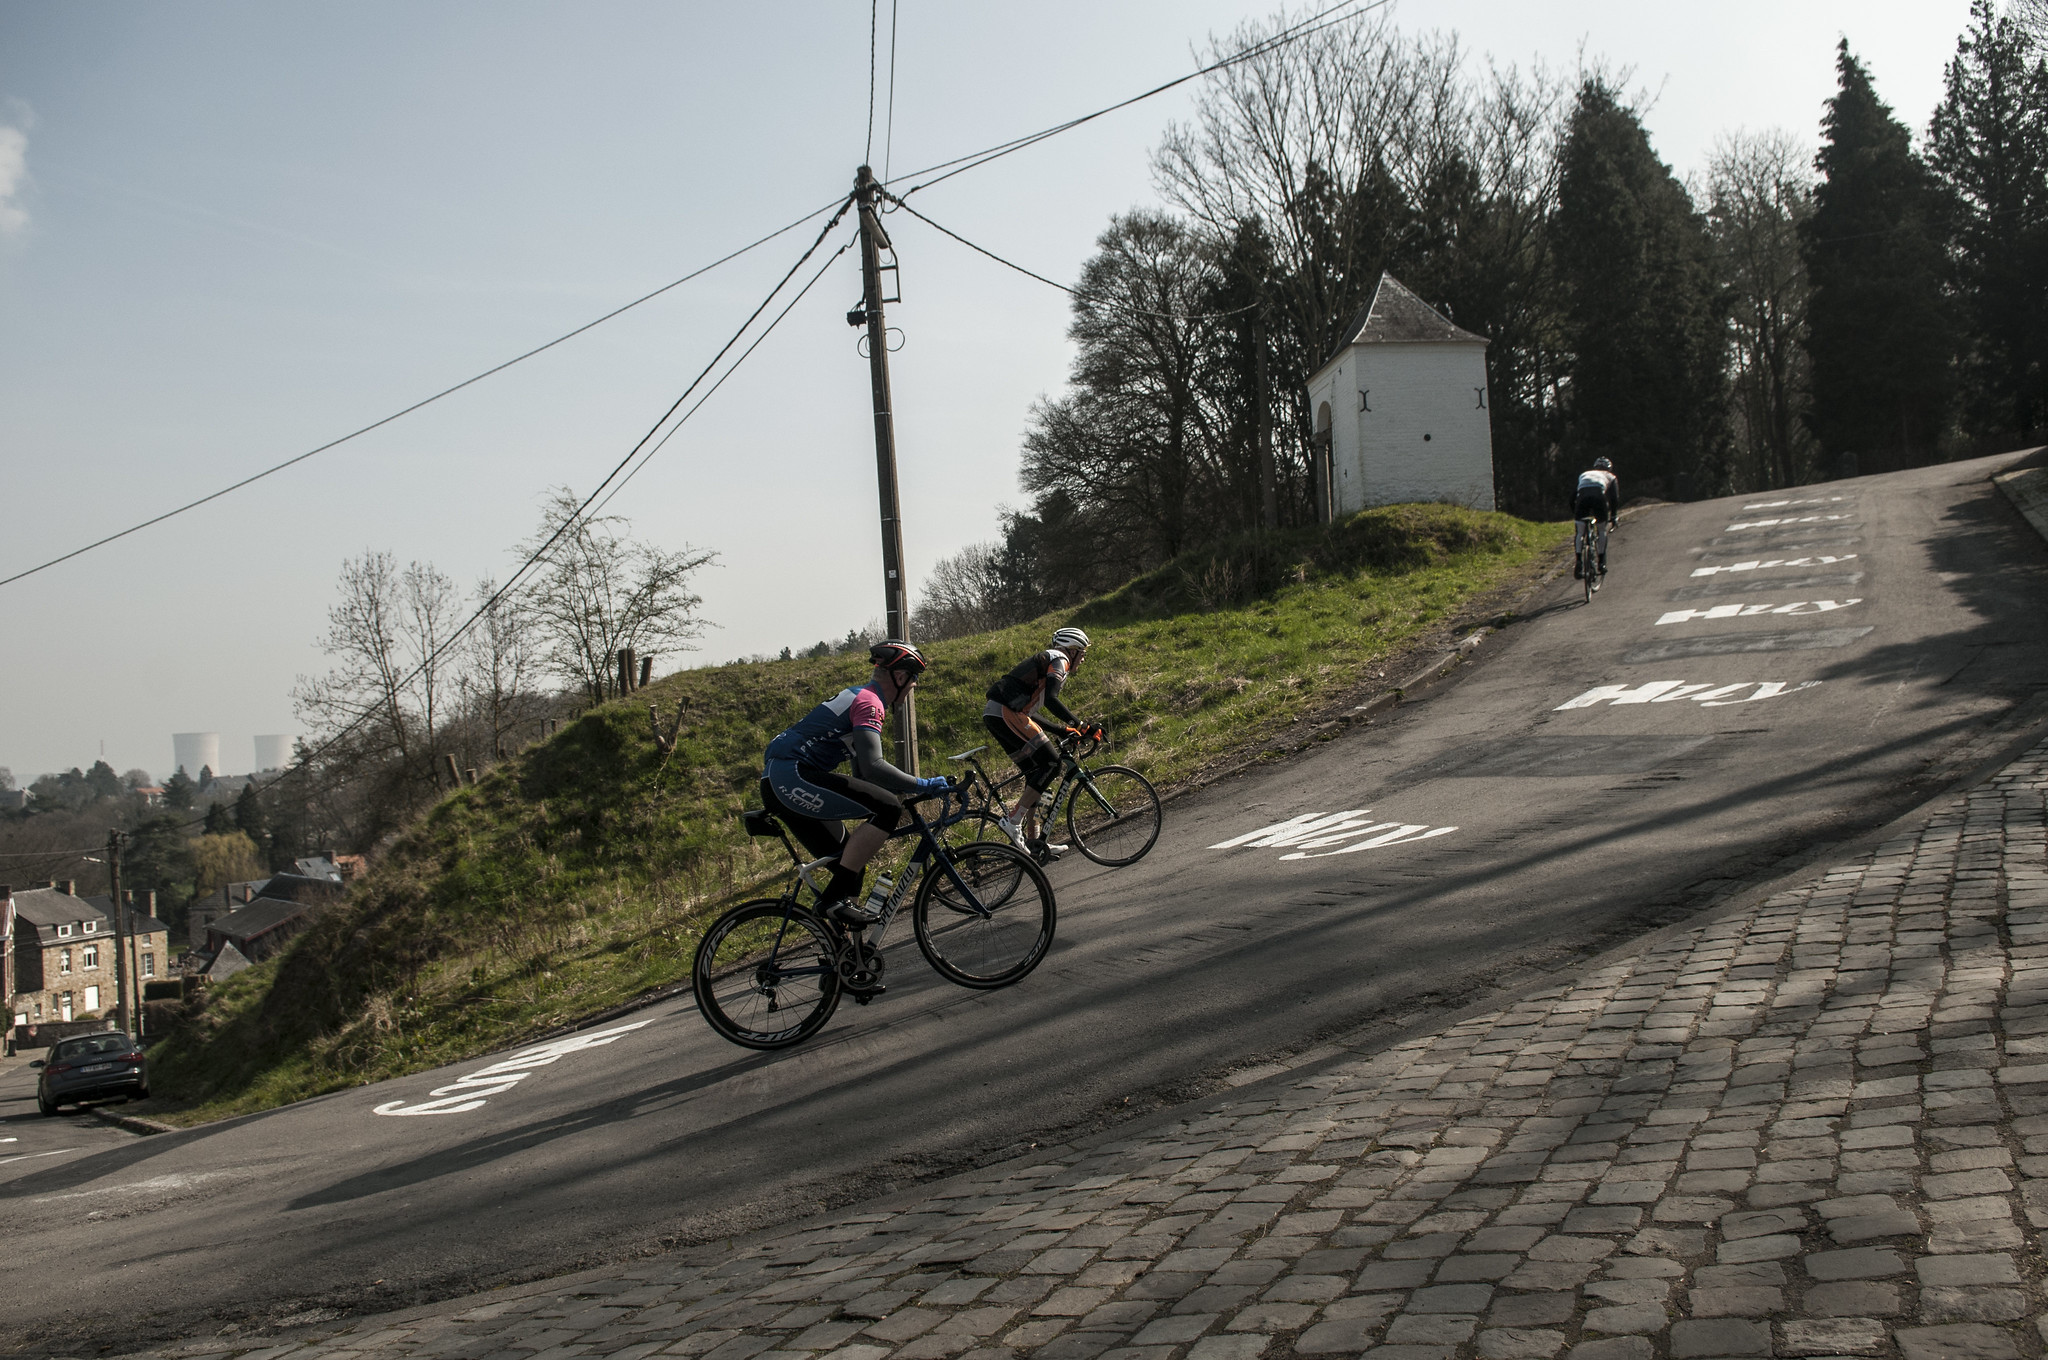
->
xmin=0 ymin=459 xmax=2048 ymax=1354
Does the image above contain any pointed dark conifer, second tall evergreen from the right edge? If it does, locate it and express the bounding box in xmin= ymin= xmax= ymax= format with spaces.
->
xmin=1802 ymin=39 xmax=1954 ymax=473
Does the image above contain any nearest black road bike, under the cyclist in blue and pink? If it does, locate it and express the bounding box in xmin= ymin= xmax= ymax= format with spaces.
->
xmin=690 ymin=793 xmax=1057 ymax=1049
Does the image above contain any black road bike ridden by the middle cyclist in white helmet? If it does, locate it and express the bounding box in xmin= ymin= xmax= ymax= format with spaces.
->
xmin=946 ymin=731 xmax=1161 ymax=868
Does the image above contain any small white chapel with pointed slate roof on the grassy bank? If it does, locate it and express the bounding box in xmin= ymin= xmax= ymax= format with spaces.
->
xmin=1309 ymin=274 xmax=1493 ymax=518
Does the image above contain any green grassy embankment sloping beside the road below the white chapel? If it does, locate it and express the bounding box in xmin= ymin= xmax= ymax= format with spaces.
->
xmin=152 ymin=506 xmax=1569 ymax=1124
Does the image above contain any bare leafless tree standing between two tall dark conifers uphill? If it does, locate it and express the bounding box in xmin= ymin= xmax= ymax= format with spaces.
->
xmin=1706 ymin=129 xmax=1815 ymax=490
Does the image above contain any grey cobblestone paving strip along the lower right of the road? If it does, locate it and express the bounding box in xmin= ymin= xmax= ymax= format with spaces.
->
xmin=132 ymin=741 xmax=2048 ymax=1360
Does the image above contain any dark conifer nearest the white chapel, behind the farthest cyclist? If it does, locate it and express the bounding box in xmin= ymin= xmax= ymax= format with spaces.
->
xmin=1552 ymin=80 xmax=1726 ymax=494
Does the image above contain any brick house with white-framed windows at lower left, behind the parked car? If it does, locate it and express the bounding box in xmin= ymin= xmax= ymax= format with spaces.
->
xmin=6 ymin=883 xmax=170 ymax=1026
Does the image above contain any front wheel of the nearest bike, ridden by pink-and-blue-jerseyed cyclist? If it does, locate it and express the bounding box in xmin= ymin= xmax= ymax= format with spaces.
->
xmin=911 ymin=842 xmax=1055 ymax=987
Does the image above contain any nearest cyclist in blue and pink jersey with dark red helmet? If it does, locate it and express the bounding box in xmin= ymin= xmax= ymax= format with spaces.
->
xmin=762 ymin=637 xmax=952 ymax=926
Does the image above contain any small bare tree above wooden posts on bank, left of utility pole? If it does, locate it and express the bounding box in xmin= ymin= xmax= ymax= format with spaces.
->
xmin=520 ymin=487 xmax=717 ymax=703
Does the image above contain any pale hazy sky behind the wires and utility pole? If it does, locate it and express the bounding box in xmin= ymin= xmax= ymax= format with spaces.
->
xmin=0 ymin=0 xmax=1968 ymax=782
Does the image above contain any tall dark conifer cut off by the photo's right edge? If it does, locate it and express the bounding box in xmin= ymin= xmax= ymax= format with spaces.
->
xmin=1927 ymin=0 xmax=2048 ymax=436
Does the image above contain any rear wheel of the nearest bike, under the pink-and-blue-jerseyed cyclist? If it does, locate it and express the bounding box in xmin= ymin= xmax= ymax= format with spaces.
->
xmin=690 ymin=899 xmax=840 ymax=1049
